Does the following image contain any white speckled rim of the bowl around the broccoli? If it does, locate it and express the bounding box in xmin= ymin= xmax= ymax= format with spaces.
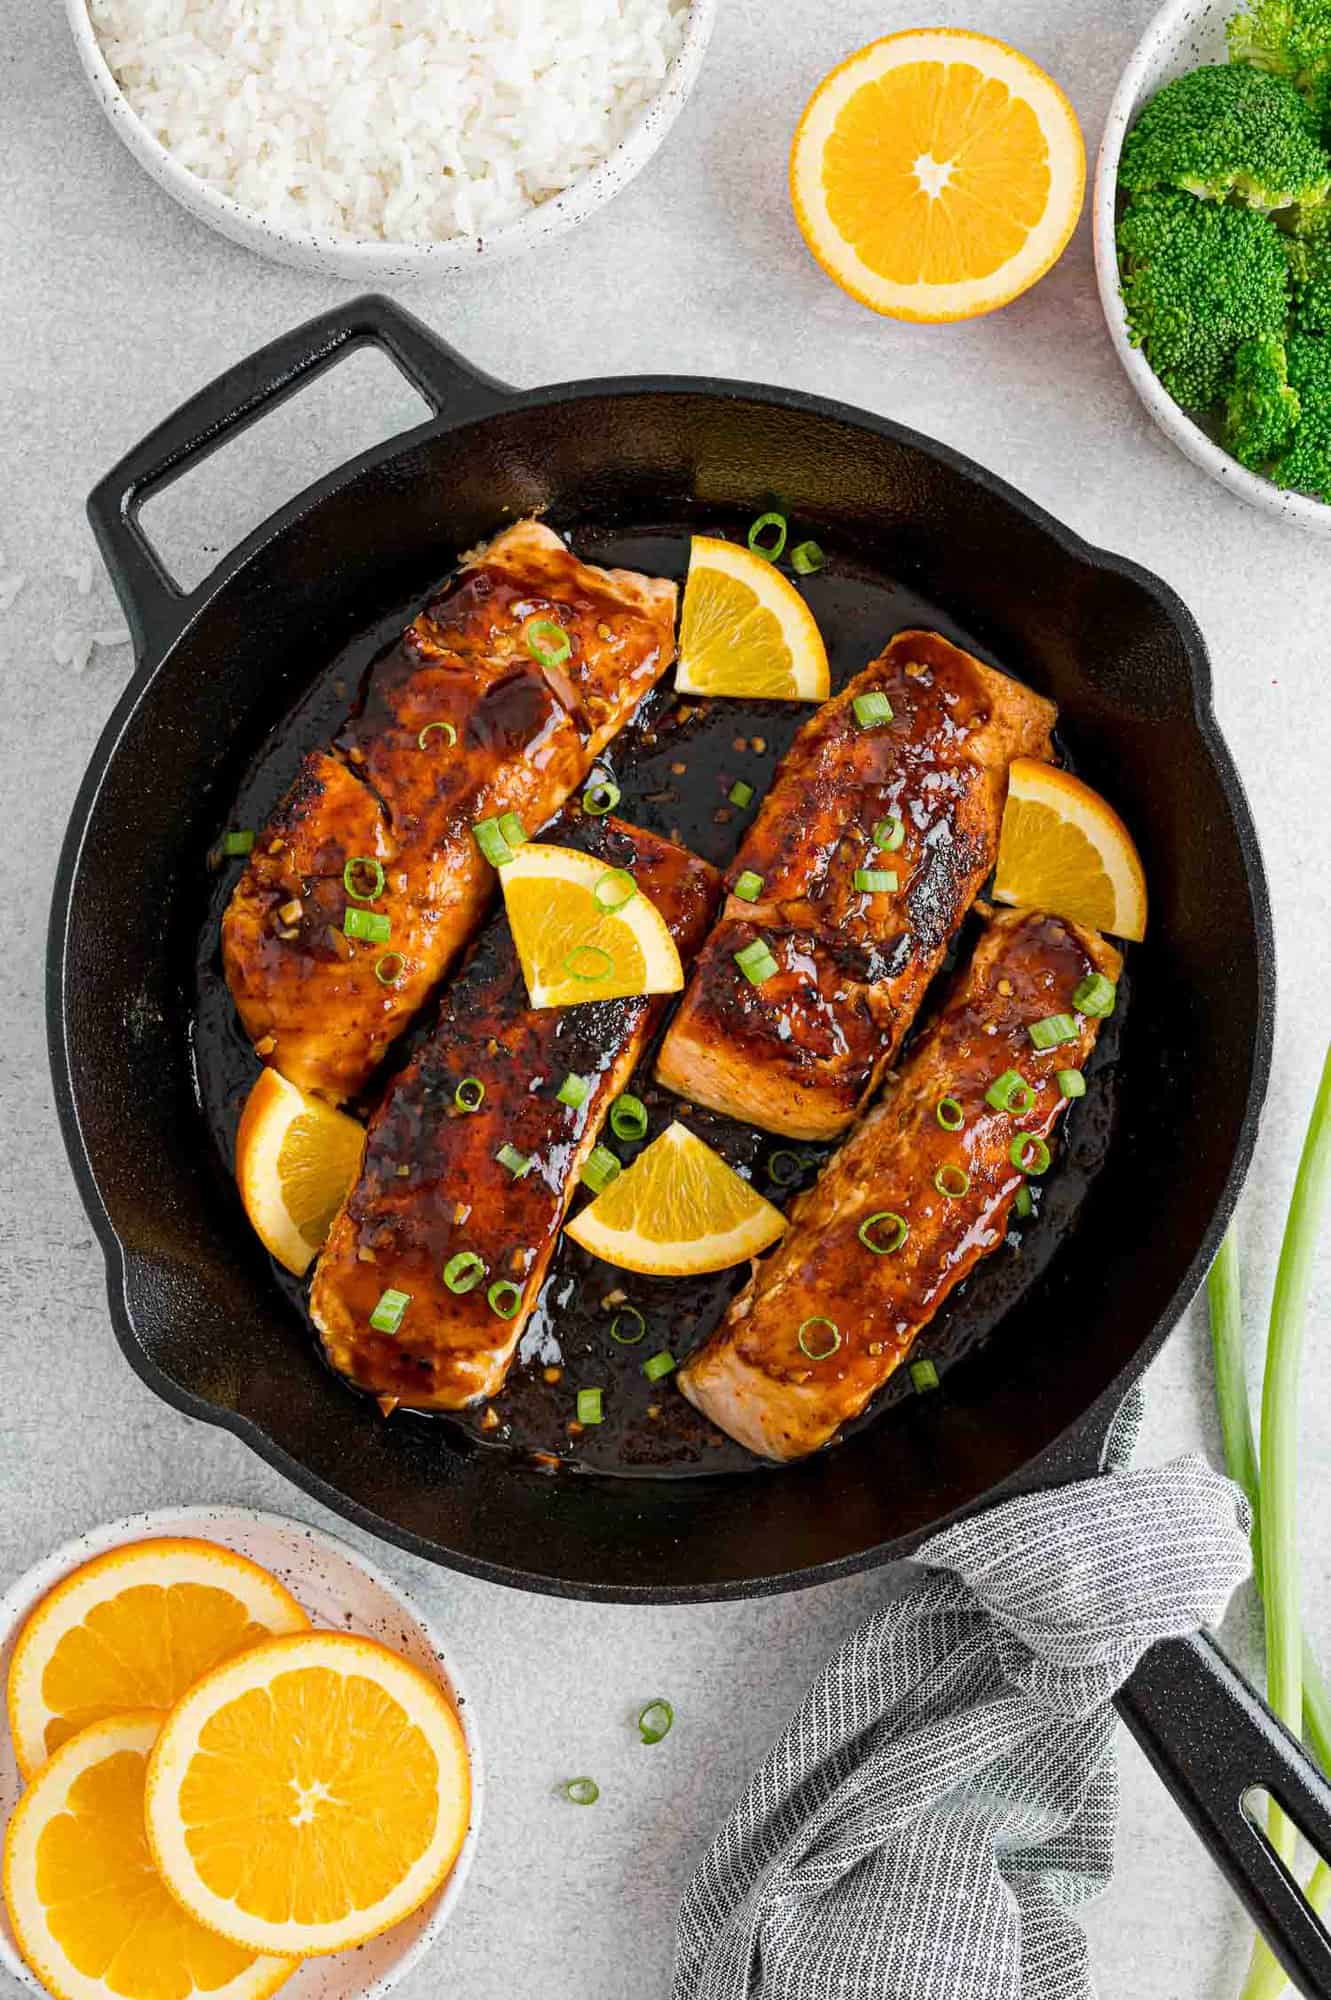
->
xmin=1093 ymin=0 xmax=1331 ymax=534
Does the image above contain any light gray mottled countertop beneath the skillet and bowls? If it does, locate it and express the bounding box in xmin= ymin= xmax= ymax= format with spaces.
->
xmin=0 ymin=0 xmax=1331 ymax=2000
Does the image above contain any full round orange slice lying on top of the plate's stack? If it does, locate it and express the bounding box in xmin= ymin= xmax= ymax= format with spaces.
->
xmin=144 ymin=1632 xmax=472 ymax=1956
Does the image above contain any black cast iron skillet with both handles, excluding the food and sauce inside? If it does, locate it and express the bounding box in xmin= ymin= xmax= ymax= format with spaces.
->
xmin=48 ymin=298 xmax=1331 ymax=1996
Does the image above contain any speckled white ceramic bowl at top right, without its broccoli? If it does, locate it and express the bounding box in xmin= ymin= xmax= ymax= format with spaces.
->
xmin=1093 ymin=0 xmax=1331 ymax=534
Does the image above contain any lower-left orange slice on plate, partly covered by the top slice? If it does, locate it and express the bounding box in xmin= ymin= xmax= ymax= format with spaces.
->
xmin=4 ymin=1712 xmax=296 ymax=2000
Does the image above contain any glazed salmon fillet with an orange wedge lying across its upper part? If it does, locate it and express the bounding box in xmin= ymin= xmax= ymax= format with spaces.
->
xmin=310 ymin=818 xmax=719 ymax=1410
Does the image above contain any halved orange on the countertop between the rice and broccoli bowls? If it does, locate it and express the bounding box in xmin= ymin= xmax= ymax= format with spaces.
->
xmin=789 ymin=28 xmax=1085 ymax=320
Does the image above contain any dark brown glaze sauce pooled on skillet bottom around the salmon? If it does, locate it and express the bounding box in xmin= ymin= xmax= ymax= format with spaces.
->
xmin=190 ymin=516 xmax=1129 ymax=1476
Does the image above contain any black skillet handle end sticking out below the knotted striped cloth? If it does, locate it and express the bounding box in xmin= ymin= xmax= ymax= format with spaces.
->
xmin=1117 ymin=1636 xmax=1331 ymax=2000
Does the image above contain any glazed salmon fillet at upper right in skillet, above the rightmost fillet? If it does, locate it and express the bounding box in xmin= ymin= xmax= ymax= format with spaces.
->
xmin=658 ymin=632 xmax=1055 ymax=1138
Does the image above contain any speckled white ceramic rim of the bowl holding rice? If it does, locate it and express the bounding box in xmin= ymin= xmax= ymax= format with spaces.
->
xmin=66 ymin=0 xmax=719 ymax=286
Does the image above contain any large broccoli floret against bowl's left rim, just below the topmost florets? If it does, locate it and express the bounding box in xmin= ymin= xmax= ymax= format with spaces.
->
xmin=1117 ymin=192 xmax=1289 ymax=410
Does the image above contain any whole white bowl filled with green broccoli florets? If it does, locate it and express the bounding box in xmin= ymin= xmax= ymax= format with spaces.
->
xmin=1095 ymin=0 xmax=1331 ymax=534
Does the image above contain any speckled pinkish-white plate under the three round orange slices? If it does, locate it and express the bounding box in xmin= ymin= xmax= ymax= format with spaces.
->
xmin=0 ymin=1506 xmax=484 ymax=2000
